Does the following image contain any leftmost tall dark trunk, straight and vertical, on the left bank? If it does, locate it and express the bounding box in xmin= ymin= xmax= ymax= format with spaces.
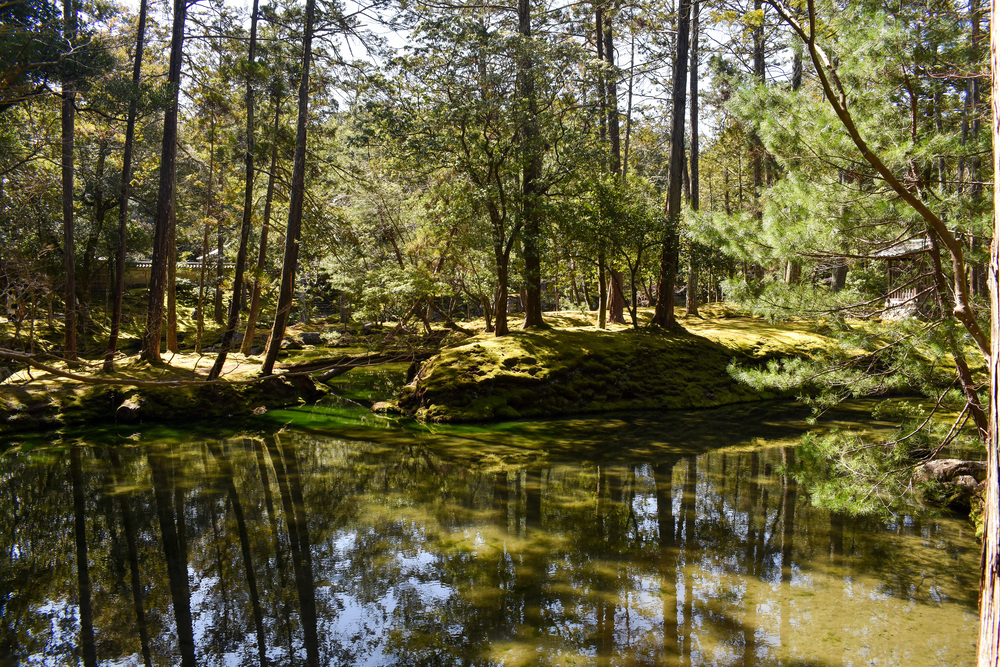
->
xmin=62 ymin=0 xmax=76 ymax=359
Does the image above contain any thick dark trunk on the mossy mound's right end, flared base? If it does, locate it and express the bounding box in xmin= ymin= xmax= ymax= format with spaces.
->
xmin=653 ymin=0 xmax=691 ymax=331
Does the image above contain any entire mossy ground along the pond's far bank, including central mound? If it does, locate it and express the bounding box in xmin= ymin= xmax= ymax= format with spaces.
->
xmin=0 ymin=304 xmax=932 ymax=434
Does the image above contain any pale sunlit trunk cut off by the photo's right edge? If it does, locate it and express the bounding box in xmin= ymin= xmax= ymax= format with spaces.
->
xmin=977 ymin=3 xmax=1000 ymax=667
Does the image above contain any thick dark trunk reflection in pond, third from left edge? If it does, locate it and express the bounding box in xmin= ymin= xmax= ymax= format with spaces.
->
xmin=148 ymin=450 xmax=196 ymax=667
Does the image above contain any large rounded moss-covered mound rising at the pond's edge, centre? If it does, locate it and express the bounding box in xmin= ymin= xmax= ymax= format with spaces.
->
xmin=399 ymin=327 xmax=829 ymax=422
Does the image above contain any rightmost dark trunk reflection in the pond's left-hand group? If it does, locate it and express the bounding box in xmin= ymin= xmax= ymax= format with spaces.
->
xmin=267 ymin=436 xmax=319 ymax=667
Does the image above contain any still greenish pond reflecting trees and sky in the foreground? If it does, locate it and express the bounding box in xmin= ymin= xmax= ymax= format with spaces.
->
xmin=0 ymin=406 xmax=979 ymax=666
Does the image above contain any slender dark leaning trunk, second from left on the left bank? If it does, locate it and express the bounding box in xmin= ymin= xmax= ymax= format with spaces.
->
xmin=104 ymin=0 xmax=146 ymax=373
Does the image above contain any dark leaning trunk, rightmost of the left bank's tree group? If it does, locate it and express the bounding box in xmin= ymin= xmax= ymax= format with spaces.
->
xmin=261 ymin=0 xmax=316 ymax=375
